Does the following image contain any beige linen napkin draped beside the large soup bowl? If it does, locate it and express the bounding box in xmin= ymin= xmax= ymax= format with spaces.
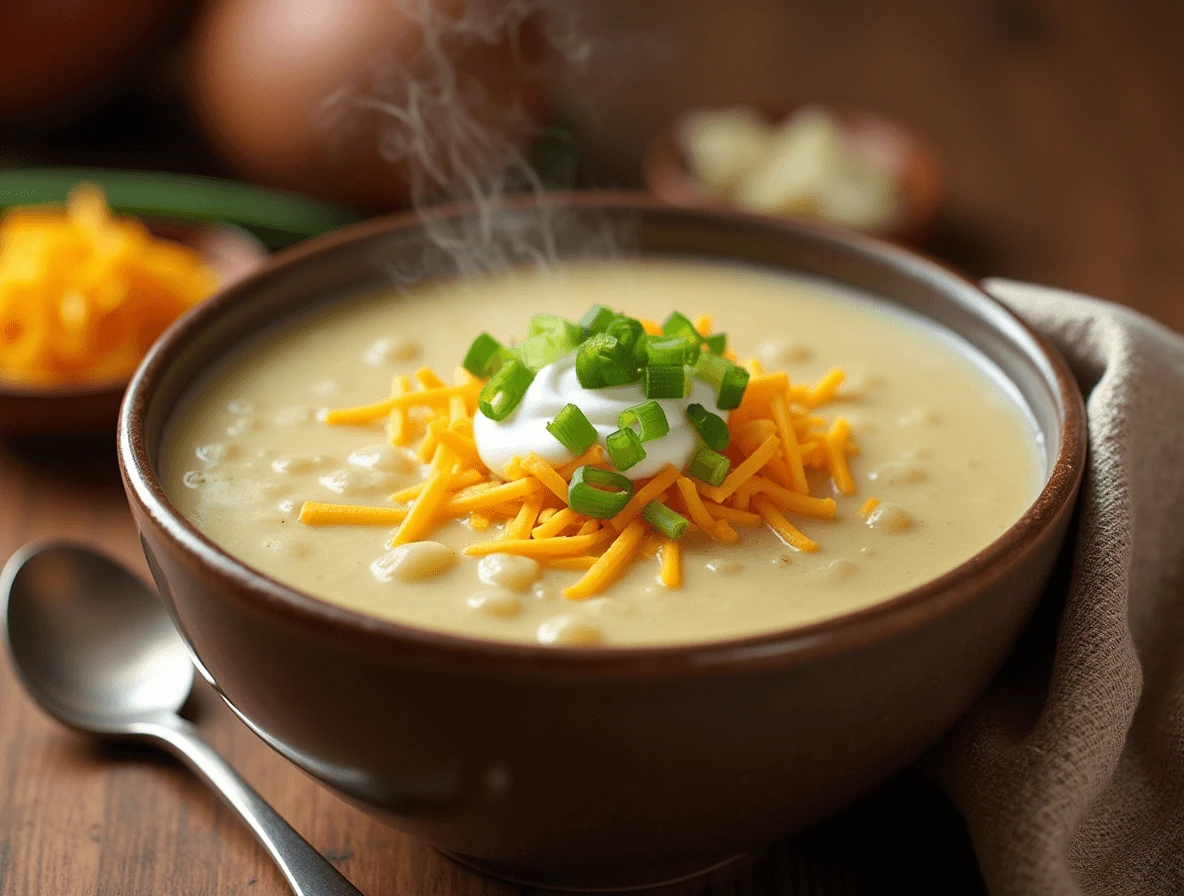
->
xmin=927 ymin=281 xmax=1184 ymax=896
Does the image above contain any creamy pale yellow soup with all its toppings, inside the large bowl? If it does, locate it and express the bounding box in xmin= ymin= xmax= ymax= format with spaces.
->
xmin=162 ymin=262 xmax=1044 ymax=645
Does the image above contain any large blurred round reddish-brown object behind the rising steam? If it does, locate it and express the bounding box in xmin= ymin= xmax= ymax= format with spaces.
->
xmin=189 ymin=0 xmax=545 ymax=210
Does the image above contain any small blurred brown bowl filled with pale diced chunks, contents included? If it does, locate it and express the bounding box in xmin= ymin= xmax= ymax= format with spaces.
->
xmin=645 ymin=105 xmax=945 ymax=244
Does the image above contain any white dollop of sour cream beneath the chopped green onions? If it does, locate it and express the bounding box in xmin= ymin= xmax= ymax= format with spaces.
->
xmin=472 ymin=354 xmax=728 ymax=479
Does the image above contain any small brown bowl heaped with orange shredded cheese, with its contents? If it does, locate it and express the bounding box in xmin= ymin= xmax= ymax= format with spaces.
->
xmin=0 ymin=183 xmax=268 ymax=436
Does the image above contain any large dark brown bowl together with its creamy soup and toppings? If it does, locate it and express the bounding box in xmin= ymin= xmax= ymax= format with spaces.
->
xmin=120 ymin=194 xmax=1086 ymax=888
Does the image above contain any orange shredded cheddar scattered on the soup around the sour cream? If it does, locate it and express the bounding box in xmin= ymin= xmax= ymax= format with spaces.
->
xmin=300 ymin=315 xmax=877 ymax=600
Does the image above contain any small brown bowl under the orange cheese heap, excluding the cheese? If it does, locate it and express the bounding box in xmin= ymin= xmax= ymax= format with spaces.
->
xmin=0 ymin=220 xmax=268 ymax=437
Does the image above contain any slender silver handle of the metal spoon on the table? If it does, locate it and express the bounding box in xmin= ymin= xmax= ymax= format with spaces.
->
xmin=139 ymin=716 xmax=362 ymax=896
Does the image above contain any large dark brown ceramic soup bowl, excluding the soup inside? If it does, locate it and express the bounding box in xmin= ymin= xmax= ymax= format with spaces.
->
xmin=120 ymin=194 xmax=1086 ymax=887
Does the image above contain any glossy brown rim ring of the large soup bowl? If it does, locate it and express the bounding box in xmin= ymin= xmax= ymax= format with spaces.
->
xmin=118 ymin=191 xmax=1087 ymax=677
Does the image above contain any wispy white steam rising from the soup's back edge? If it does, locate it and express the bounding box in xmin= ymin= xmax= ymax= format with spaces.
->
xmin=322 ymin=0 xmax=631 ymax=275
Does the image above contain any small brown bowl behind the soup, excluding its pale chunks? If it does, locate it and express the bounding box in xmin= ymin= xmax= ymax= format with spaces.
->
xmin=644 ymin=108 xmax=946 ymax=245
